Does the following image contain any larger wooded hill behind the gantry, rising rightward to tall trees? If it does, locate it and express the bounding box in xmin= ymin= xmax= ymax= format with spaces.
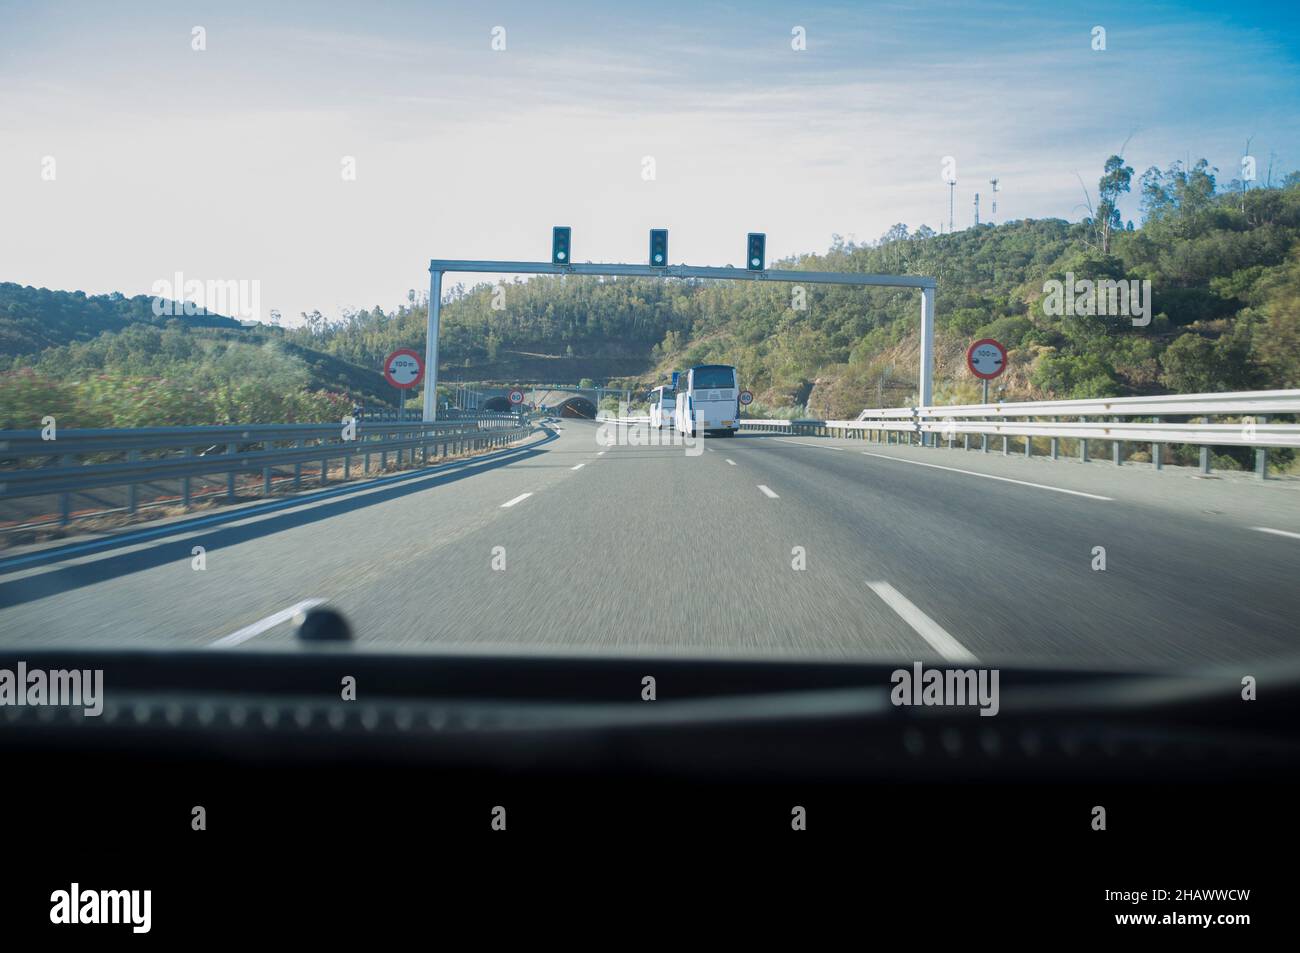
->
xmin=291 ymin=157 xmax=1300 ymax=415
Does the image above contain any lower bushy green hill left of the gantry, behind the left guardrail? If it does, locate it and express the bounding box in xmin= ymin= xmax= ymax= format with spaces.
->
xmin=0 ymin=283 xmax=393 ymax=429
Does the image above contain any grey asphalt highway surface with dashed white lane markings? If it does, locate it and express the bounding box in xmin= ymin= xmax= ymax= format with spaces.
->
xmin=0 ymin=420 xmax=1300 ymax=673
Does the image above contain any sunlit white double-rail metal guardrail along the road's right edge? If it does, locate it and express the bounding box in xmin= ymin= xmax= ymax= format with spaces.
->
xmin=741 ymin=390 xmax=1300 ymax=478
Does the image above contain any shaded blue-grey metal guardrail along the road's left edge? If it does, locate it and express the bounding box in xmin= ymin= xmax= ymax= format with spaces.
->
xmin=0 ymin=413 xmax=532 ymax=524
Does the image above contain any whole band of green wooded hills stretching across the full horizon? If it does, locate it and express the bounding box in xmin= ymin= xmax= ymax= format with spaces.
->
xmin=0 ymin=156 xmax=1300 ymax=423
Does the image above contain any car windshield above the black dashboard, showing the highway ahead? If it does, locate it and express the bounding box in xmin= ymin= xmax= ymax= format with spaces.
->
xmin=0 ymin=0 xmax=1300 ymax=694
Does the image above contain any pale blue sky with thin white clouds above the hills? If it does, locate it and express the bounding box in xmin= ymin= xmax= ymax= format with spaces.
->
xmin=0 ymin=0 xmax=1300 ymax=323
